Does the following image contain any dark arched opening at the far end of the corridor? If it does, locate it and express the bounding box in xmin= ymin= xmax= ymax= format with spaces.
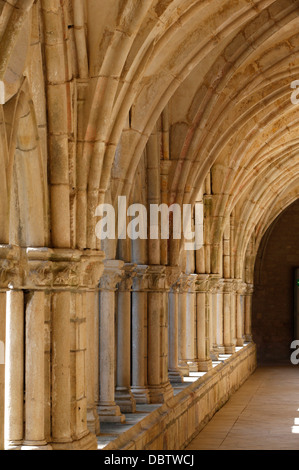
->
xmin=252 ymin=199 xmax=299 ymax=364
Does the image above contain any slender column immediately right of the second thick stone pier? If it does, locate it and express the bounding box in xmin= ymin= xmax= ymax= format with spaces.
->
xmin=168 ymin=268 xmax=183 ymax=383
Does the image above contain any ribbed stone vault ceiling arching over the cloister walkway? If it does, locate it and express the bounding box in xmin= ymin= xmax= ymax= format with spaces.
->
xmin=0 ymin=0 xmax=299 ymax=269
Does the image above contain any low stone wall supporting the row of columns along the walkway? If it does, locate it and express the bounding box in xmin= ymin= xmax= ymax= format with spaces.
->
xmin=103 ymin=343 xmax=256 ymax=450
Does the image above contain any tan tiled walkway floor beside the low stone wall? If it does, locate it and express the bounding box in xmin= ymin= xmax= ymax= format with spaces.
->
xmin=187 ymin=366 xmax=299 ymax=450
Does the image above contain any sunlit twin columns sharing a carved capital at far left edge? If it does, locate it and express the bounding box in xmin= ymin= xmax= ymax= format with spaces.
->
xmin=0 ymin=246 xmax=52 ymax=450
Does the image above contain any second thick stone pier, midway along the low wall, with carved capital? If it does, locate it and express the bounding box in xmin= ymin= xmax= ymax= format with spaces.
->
xmin=147 ymin=266 xmax=173 ymax=403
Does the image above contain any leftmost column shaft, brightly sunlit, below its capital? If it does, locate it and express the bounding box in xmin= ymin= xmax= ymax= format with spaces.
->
xmin=4 ymin=290 xmax=24 ymax=449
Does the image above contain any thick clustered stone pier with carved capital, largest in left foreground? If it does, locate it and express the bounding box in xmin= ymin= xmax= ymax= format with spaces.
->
xmin=50 ymin=249 xmax=104 ymax=450
